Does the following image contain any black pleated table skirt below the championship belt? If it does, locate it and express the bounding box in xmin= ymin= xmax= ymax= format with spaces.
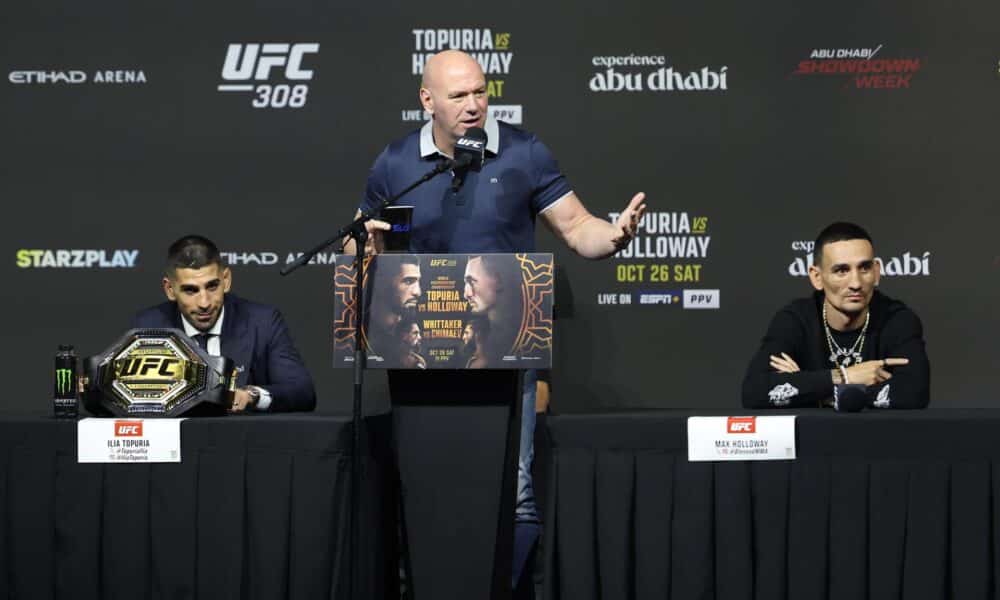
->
xmin=0 ymin=416 xmax=396 ymax=600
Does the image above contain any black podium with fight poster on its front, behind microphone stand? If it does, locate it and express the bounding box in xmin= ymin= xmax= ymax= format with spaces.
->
xmin=334 ymin=254 xmax=553 ymax=600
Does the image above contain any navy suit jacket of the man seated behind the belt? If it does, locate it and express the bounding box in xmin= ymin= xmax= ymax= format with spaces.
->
xmin=132 ymin=294 xmax=316 ymax=412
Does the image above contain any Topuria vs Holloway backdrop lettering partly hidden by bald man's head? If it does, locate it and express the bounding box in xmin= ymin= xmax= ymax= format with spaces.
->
xmin=400 ymin=28 xmax=524 ymax=125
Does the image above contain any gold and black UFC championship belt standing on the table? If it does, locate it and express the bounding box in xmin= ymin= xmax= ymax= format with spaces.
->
xmin=83 ymin=329 xmax=236 ymax=418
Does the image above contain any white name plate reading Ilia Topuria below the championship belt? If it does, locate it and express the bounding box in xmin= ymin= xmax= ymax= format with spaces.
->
xmin=76 ymin=419 xmax=184 ymax=463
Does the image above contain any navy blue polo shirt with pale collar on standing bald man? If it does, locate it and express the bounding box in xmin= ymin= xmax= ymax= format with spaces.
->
xmin=361 ymin=117 xmax=572 ymax=253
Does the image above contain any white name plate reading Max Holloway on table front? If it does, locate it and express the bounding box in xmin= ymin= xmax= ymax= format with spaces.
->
xmin=688 ymin=415 xmax=795 ymax=462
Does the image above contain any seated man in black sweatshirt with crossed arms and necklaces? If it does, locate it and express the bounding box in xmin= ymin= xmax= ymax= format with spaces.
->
xmin=743 ymin=223 xmax=930 ymax=408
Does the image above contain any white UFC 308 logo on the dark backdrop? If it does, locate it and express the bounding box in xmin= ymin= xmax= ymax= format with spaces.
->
xmin=218 ymin=42 xmax=319 ymax=108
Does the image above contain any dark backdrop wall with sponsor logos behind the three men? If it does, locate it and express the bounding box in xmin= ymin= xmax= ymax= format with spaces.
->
xmin=0 ymin=0 xmax=1000 ymax=412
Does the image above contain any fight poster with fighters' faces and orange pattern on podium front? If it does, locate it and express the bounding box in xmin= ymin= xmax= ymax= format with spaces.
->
xmin=333 ymin=253 xmax=554 ymax=369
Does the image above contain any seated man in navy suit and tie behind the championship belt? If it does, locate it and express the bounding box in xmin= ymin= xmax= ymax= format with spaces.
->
xmin=133 ymin=235 xmax=316 ymax=412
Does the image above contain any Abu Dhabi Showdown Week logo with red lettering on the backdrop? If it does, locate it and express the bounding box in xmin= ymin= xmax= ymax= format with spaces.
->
xmin=791 ymin=44 xmax=922 ymax=90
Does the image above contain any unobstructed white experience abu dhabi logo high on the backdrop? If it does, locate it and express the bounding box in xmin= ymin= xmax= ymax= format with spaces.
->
xmin=590 ymin=54 xmax=729 ymax=92
